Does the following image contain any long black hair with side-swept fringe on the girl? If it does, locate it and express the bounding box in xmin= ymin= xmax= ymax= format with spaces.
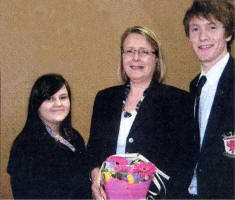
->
xmin=23 ymin=74 xmax=72 ymax=141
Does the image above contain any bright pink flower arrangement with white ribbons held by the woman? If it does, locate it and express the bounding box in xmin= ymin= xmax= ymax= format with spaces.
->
xmin=98 ymin=153 xmax=169 ymax=200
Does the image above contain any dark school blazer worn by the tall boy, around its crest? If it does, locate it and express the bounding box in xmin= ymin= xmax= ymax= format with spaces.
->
xmin=190 ymin=57 xmax=235 ymax=199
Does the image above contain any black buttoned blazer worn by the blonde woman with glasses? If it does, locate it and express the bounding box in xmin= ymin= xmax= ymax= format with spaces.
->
xmin=87 ymin=82 xmax=192 ymax=198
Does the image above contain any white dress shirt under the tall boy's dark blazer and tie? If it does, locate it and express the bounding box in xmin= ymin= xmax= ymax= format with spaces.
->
xmin=188 ymin=53 xmax=229 ymax=195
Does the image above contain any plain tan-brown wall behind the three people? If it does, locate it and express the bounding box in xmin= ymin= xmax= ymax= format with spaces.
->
xmin=0 ymin=0 xmax=234 ymax=199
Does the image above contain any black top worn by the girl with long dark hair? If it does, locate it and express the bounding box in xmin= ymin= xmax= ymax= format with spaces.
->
xmin=7 ymin=126 xmax=89 ymax=199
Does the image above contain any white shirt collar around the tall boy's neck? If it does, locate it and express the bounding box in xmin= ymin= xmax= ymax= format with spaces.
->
xmin=199 ymin=53 xmax=229 ymax=84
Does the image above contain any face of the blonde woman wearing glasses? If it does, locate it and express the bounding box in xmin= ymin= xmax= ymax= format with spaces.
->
xmin=122 ymin=33 xmax=158 ymax=83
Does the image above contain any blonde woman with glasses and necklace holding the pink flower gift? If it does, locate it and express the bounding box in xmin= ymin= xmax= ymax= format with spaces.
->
xmin=87 ymin=26 xmax=193 ymax=199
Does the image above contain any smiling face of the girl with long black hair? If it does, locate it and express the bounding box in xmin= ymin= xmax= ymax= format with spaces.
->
xmin=38 ymin=86 xmax=70 ymax=127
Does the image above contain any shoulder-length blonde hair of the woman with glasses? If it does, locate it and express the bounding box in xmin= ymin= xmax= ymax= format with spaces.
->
xmin=119 ymin=26 xmax=166 ymax=83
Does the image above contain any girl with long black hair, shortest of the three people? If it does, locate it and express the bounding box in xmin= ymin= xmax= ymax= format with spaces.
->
xmin=7 ymin=74 xmax=89 ymax=199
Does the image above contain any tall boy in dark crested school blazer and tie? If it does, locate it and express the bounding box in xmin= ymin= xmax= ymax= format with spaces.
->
xmin=183 ymin=0 xmax=235 ymax=199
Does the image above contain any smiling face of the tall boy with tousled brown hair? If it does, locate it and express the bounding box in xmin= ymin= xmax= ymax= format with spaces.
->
xmin=189 ymin=17 xmax=231 ymax=71
